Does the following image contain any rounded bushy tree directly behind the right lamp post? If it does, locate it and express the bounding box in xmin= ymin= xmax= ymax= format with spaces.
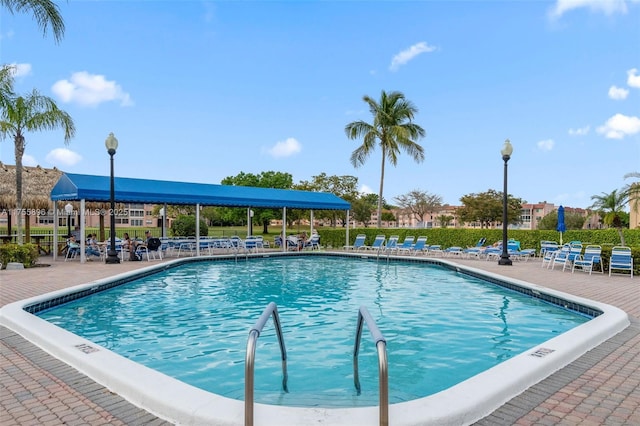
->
xmin=458 ymin=189 xmax=523 ymax=228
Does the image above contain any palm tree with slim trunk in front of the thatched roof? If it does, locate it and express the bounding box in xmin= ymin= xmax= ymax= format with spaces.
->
xmin=0 ymin=89 xmax=76 ymax=244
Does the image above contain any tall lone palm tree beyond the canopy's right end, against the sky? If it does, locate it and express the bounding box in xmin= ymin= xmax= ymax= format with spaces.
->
xmin=344 ymin=90 xmax=425 ymax=228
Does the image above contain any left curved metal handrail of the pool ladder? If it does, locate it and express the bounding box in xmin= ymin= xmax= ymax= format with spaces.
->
xmin=244 ymin=302 xmax=289 ymax=426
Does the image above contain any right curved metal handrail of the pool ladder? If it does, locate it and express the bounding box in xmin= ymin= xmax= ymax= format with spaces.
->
xmin=353 ymin=306 xmax=389 ymax=426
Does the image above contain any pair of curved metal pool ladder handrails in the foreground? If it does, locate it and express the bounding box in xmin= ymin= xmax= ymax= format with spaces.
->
xmin=244 ymin=302 xmax=389 ymax=426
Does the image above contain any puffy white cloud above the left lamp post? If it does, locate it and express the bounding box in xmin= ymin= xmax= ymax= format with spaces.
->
xmin=51 ymin=71 xmax=133 ymax=106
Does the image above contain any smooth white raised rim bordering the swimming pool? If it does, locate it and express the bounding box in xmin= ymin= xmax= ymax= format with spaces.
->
xmin=0 ymin=261 xmax=630 ymax=426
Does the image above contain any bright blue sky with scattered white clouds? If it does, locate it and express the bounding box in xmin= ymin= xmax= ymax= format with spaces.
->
xmin=0 ymin=0 xmax=640 ymax=207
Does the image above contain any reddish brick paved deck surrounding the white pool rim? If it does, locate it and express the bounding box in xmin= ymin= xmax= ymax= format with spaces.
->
xmin=0 ymin=257 xmax=640 ymax=426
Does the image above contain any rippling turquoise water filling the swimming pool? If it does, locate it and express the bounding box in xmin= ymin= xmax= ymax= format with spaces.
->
xmin=38 ymin=256 xmax=589 ymax=407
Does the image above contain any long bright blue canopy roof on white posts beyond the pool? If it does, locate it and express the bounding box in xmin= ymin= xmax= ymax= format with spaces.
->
xmin=51 ymin=173 xmax=351 ymax=210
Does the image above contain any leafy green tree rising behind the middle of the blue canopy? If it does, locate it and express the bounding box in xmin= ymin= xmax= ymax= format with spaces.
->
xmin=221 ymin=171 xmax=293 ymax=234
